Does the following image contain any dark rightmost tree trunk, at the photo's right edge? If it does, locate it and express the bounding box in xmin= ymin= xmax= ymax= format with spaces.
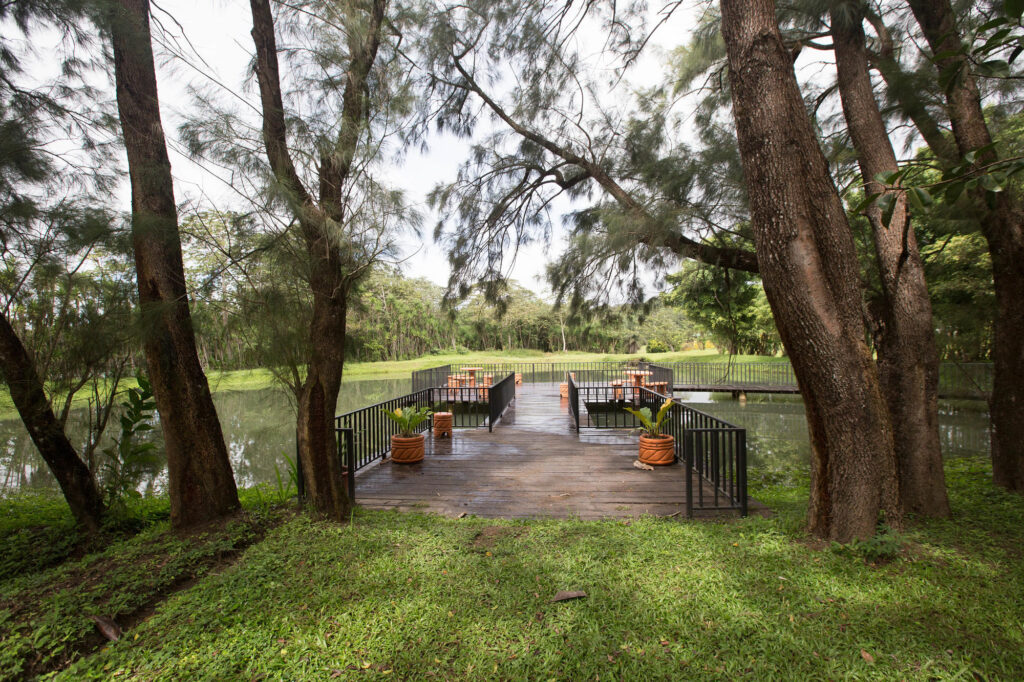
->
xmin=910 ymin=0 xmax=1024 ymax=493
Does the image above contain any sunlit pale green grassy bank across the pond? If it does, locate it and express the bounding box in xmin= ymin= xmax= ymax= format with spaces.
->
xmin=0 ymin=350 xmax=785 ymax=419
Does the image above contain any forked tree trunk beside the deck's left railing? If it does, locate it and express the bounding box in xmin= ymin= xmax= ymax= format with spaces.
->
xmin=250 ymin=0 xmax=386 ymax=520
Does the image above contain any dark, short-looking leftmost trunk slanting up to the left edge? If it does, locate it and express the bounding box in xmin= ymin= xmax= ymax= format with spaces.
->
xmin=0 ymin=315 xmax=103 ymax=532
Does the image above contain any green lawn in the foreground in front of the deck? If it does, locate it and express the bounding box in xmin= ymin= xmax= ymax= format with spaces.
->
xmin=0 ymin=460 xmax=1024 ymax=680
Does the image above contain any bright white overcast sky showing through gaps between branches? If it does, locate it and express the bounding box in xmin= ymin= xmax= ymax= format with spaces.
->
xmin=144 ymin=0 xmax=694 ymax=295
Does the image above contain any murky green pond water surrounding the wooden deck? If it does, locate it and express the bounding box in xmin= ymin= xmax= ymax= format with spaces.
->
xmin=0 ymin=379 xmax=989 ymax=495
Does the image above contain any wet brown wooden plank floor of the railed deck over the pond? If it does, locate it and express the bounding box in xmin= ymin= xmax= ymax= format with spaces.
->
xmin=355 ymin=384 xmax=749 ymax=519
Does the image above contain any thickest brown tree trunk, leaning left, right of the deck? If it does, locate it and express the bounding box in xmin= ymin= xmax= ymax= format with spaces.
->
xmin=722 ymin=0 xmax=900 ymax=542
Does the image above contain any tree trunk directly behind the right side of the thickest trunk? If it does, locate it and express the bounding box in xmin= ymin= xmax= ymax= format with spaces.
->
xmin=831 ymin=4 xmax=949 ymax=517
